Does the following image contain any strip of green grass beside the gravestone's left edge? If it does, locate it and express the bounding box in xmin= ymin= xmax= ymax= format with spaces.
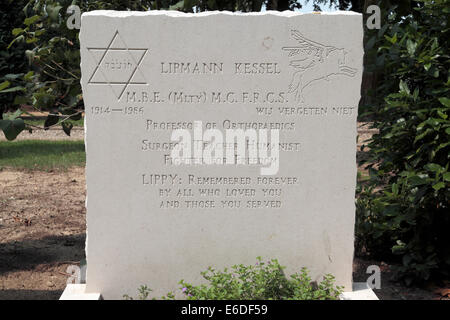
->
xmin=0 ymin=140 xmax=86 ymax=170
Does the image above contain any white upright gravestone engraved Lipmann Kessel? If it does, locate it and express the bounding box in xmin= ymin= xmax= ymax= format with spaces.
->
xmin=80 ymin=11 xmax=363 ymax=299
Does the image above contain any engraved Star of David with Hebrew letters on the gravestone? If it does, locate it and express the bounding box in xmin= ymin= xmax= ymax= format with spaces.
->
xmin=87 ymin=31 xmax=148 ymax=100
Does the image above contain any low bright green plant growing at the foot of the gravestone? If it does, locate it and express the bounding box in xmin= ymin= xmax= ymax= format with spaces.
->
xmin=124 ymin=257 xmax=342 ymax=300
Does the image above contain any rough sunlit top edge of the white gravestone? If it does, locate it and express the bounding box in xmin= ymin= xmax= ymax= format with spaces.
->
xmin=83 ymin=10 xmax=361 ymax=18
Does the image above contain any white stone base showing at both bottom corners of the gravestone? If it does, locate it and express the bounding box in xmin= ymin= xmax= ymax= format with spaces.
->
xmin=59 ymin=282 xmax=379 ymax=300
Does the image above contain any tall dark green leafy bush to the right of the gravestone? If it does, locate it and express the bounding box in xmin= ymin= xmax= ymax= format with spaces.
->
xmin=356 ymin=0 xmax=450 ymax=283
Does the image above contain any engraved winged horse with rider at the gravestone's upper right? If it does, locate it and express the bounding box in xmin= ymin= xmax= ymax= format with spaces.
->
xmin=282 ymin=30 xmax=357 ymax=103
